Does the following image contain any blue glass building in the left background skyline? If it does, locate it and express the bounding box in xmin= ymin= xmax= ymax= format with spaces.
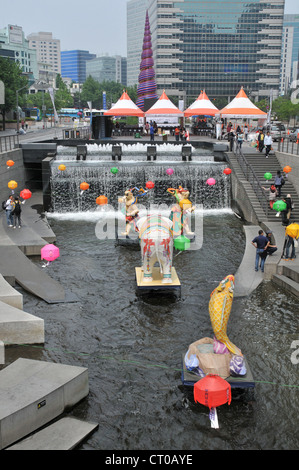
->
xmin=61 ymin=50 xmax=96 ymax=83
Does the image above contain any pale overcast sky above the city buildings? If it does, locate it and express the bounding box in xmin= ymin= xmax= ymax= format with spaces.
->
xmin=0 ymin=0 xmax=299 ymax=56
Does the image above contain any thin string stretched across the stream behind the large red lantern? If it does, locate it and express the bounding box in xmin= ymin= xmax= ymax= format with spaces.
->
xmin=5 ymin=343 xmax=299 ymax=389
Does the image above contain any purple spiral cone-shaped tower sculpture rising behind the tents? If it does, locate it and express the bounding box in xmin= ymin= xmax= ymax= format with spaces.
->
xmin=136 ymin=12 xmax=158 ymax=110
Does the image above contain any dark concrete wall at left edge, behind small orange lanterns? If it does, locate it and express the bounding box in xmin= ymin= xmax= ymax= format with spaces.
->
xmin=0 ymin=149 xmax=25 ymax=211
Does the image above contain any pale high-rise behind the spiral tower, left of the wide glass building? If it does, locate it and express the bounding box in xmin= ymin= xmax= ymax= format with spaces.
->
xmin=127 ymin=0 xmax=148 ymax=86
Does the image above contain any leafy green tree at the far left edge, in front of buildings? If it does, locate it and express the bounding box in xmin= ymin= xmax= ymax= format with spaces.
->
xmin=0 ymin=57 xmax=28 ymax=130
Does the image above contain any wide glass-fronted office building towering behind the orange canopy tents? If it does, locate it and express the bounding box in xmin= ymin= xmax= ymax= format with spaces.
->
xmin=148 ymin=0 xmax=284 ymax=104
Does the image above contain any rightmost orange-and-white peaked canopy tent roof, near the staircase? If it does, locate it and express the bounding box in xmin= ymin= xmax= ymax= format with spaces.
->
xmin=219 ymin=87 xmax=267 ymax=119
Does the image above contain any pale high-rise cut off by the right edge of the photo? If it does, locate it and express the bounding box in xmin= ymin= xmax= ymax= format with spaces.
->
xmin=280 ymin=14 xmax=299 ymax=95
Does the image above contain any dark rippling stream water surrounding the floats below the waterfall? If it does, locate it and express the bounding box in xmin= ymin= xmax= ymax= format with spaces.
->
xmin=6 ymin=211 xmax=299 ymax=450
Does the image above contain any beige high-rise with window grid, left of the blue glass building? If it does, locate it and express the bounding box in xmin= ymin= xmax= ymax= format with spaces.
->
xmin=27 ymin=32 xmax=61 ymax=74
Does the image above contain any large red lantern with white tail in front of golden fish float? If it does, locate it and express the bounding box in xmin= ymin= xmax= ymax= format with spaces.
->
xmin=193 ymin=374 xmax=231 ymax=428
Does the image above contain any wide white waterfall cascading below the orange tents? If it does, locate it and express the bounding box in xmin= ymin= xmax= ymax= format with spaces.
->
xmin=50 ymin=144 xmax=230 ymax=213
